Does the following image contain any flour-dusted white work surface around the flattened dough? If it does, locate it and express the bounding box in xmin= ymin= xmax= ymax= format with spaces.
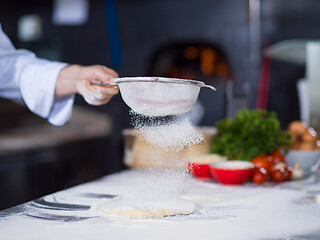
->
xmin=0 ymin=170 xmax=320 ymax=240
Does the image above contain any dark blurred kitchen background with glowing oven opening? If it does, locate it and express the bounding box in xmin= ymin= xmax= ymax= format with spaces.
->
xmin=0 ymin=0 xmax=320 ymax=209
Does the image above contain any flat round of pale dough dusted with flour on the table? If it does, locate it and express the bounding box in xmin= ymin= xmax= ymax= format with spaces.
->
xmin=92 ymin=196 xmax=195 ymax=218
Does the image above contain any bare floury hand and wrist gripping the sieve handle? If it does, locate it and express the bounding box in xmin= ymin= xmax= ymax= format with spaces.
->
xmin=55 ymin=65 xmax=119 ymax=105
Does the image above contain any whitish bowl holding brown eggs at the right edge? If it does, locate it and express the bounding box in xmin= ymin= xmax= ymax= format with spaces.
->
xmin=285 ymin=150 xmax=320 ymax=177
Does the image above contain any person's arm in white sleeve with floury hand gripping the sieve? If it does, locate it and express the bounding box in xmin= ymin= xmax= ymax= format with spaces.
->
xmin=0 ymin=24 xmax=119 ymax=126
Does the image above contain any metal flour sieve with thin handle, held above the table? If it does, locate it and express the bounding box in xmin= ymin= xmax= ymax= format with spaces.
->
xmin=94 ymin=77 xmax=216 ymax=116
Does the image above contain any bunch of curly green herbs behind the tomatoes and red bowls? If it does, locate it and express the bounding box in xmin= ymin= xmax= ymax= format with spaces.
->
xmin=211 ymin=109 xmax=291 ymax=161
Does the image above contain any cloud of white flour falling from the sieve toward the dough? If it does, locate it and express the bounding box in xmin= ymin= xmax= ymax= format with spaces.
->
xmin=125 ymin=111 xmax=204 ymax=216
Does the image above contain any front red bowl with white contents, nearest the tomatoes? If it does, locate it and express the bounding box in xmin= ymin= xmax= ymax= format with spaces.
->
xmin=210 ymin=161 xmax=254 ymax=185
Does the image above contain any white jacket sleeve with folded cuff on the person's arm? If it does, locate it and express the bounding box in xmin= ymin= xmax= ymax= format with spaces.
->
xmin=0 ymin=24 xmax=74 ymax=126
